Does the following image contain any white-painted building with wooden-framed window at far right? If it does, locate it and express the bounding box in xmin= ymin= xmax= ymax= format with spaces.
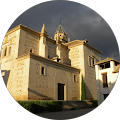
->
xmin=94 ymin=58 xmax=120 ymax=105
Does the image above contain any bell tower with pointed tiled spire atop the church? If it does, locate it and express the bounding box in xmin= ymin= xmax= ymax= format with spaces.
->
xmin=54 ymin=22 xmax=67 ymax=43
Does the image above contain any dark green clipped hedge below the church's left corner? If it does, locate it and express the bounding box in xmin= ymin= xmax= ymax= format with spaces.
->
xmin=17 ymin=101 xmax=62 ymax=114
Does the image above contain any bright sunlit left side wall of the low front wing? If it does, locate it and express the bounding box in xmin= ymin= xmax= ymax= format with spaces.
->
xmin=7 ymin=58 xmax=29 ymax=100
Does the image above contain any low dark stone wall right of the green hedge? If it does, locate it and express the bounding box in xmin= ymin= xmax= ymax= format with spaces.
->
xmin=62 ymin=100 xmax=97 ymax=110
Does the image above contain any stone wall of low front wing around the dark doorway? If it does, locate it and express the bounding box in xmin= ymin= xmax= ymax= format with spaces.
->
xmin=28 ymin=58 xmax=80 ymax=100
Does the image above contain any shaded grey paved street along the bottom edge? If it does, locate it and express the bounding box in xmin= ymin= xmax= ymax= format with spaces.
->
xmin=36 ymin=108 xmax=95 ymax=120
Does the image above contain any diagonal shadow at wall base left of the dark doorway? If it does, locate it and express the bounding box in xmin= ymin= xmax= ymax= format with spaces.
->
xmin=28 ymin=88 xmax=53 ymax=100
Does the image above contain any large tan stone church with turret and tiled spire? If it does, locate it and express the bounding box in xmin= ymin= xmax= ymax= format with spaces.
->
xmin=1 ymin=24 xmax=102 ymax=100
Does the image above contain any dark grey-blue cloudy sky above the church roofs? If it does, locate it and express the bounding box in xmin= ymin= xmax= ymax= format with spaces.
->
xmin=9 ymin=1 xmax=120 ymax=61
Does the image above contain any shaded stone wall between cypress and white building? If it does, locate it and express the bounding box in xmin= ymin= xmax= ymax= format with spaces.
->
xmin=84 ymin=46 xmax=101 ymax=100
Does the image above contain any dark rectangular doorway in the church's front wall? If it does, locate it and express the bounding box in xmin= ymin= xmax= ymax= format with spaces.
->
xmin=58 ymin=83 xmax=65 ymax=100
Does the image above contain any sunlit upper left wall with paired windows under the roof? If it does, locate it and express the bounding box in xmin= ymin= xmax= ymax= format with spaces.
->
xmin=1 ymin=30 xmax=20 ymax=62
